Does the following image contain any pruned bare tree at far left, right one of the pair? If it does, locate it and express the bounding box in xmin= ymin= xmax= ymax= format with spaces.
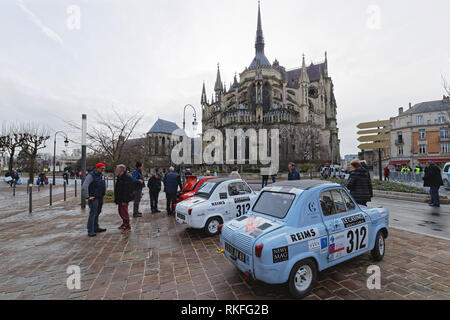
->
xmin=20 ymin=123 xmax=50 ymax=184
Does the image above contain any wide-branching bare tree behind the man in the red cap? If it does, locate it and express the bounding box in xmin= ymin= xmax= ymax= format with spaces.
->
xmin=66 ymin=109 xmax=143 ymax=180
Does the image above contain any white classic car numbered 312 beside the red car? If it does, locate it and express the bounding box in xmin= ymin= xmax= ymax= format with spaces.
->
xmin=176 ymin=179 xmax=257 ymax=236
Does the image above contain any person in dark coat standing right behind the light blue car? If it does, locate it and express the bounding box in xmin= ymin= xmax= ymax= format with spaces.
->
xmin=347 ymin=160 xmax=373 ymax=206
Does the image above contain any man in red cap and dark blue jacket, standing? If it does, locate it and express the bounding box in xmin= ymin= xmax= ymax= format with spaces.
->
xmin=82 ymin=163 xmax=106 ymax=237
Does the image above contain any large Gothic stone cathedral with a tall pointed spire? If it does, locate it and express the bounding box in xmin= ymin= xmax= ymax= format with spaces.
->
xmin=201 ymin=5 xmax=340 ymax=168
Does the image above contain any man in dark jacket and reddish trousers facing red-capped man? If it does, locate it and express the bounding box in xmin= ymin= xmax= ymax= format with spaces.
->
xmin=114 ymin=164 xmax=135 ymax=234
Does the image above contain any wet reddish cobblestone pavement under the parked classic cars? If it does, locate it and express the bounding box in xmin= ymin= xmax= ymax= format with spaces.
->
xmin=0 ymin=195 xmax=450 ymax=300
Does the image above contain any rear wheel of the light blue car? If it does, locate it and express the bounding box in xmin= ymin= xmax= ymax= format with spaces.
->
xmin=289 ymin=259 xmax=317 ymax=299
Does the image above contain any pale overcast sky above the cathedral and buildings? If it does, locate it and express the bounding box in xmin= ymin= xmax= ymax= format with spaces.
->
xmin=0 ymin=0 xmax=450 ymax=156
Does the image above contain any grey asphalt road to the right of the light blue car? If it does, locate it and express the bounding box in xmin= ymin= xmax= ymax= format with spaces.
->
xmin=250 ymin=183 xmax=450 ymax=240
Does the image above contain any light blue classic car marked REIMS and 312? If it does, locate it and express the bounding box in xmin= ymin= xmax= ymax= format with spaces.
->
xmin=219 ymin=180 xmax=389 ymax=298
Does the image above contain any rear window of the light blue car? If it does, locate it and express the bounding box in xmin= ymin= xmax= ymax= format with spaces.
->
xmin=253 ymin=191 xmax=295 ymax=219
